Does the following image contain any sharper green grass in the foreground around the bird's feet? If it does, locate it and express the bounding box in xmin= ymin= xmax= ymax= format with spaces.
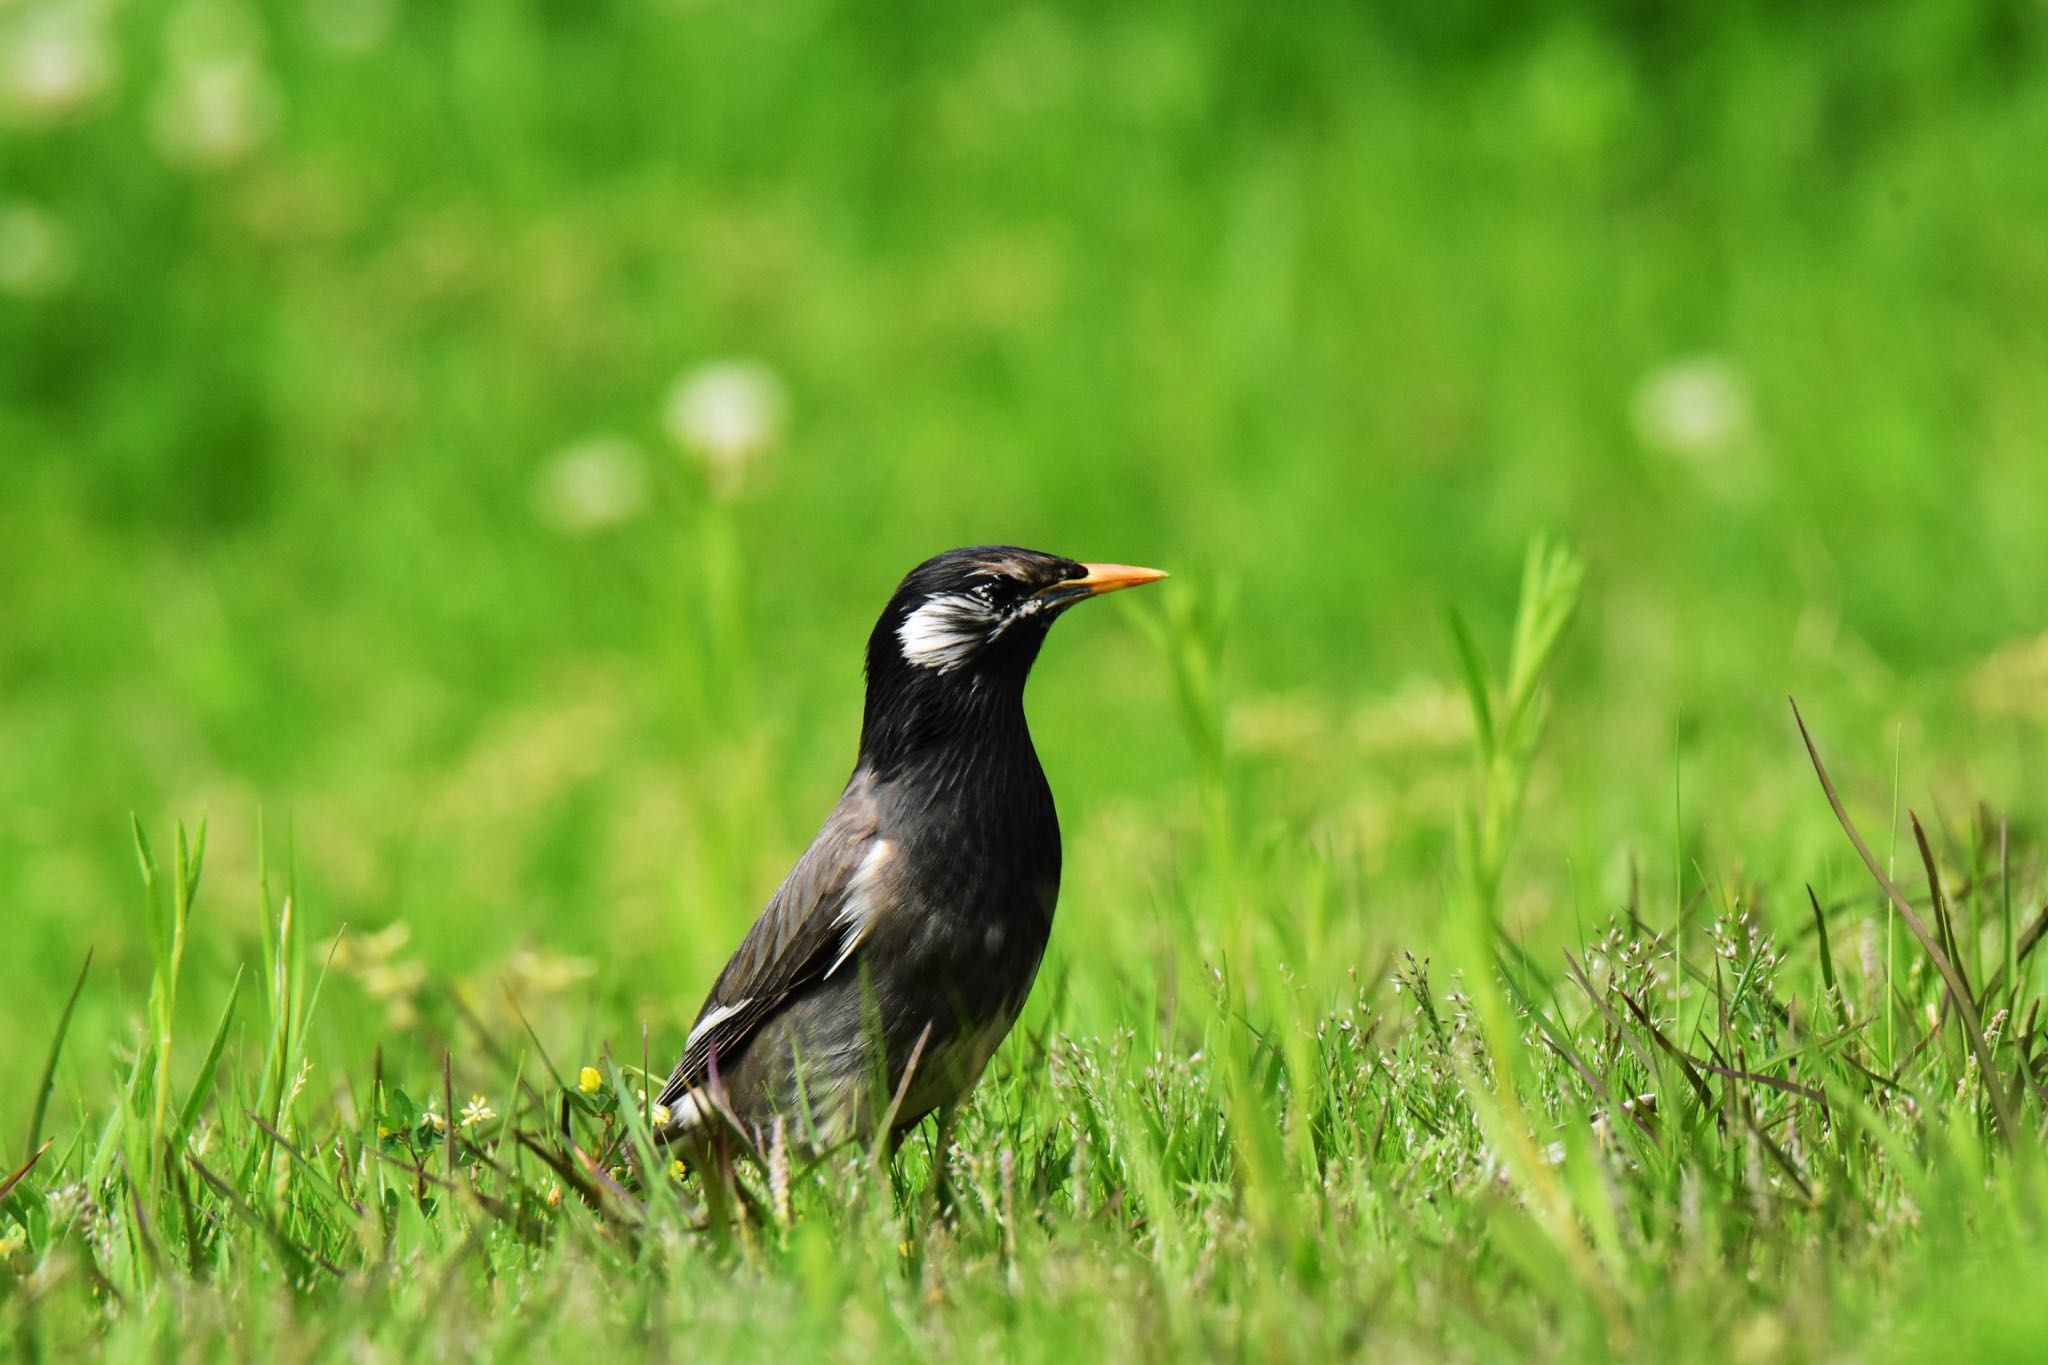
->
xmin=12 ymin=546 xmax=2048 ymax=1359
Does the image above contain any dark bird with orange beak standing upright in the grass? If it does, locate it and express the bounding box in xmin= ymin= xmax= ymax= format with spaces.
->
xmin=653 ymin=544 xmax=1167 ymax=1156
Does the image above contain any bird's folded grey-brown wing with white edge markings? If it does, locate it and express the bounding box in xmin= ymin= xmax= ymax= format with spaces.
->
xmin=657 ymin=774 xmax=895 ymax=1105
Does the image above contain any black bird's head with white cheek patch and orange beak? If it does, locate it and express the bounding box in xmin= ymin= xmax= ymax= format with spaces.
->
xmin=851 ymin=544 xmax=1165 ymax=765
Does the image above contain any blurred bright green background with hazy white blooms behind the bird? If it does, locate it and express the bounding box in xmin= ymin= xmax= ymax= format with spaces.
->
xmin=0 ymin=0 xmax=2048 ymax=1107
